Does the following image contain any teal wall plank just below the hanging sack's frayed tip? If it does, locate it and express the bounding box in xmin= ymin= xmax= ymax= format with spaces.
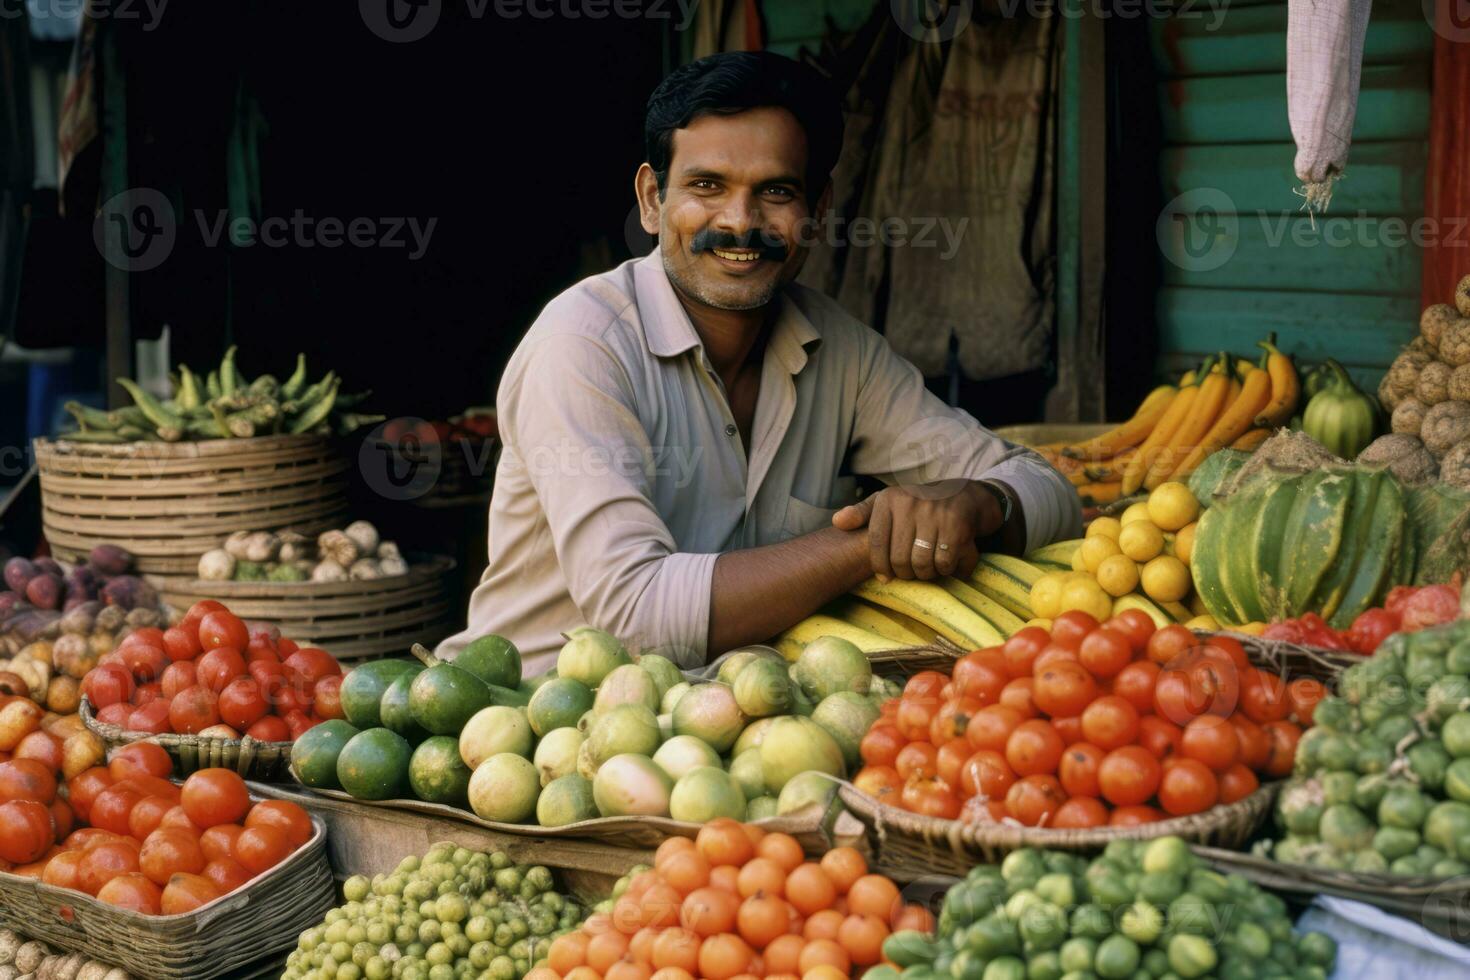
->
xmin=1160 ymin=206 xmax=1423 ymax=295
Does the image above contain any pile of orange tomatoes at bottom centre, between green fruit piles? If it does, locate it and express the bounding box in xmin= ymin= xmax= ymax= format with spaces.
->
xmin=526 ymin=817 xmax=933 ymax=980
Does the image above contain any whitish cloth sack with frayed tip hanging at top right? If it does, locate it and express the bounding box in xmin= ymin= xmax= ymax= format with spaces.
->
xmin=1286 ymin=0 xmax=1373 ymax=212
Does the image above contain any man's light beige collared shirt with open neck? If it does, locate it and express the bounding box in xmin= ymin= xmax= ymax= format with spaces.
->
xmin=440 ymin=251 xmax=1080 ymax=676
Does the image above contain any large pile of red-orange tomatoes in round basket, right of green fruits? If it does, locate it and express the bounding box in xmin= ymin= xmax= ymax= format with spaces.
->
xmin=853 ymin=610 xmax=1326 ymax=827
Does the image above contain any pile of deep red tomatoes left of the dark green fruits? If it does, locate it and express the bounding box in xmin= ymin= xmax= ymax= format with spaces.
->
xmin=82 ymin=599 xmax=343 ymax=742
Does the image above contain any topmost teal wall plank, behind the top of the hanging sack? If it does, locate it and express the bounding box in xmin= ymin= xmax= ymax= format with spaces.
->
xmin=1148 ymin=0 xmax=1435 ymax=78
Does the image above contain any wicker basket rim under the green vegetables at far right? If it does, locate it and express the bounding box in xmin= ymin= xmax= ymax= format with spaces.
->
xmin=1194 ymin=846 xmax=1470 ymax=943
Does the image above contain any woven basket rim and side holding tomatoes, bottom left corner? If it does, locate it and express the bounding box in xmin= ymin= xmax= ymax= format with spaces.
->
xmin=0 ymin=817 xmax=337 ymax=980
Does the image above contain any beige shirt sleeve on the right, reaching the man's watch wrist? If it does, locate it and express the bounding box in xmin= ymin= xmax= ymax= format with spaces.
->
xmin=853 ymin=334 xmax=1082 ymax=551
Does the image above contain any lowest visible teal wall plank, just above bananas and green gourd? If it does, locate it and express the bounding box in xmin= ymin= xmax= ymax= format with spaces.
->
xmin=1155 ymin=288 xmax=1419 ymax=369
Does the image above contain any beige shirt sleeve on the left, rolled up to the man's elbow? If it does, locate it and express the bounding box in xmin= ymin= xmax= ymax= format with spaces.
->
xmin=501 ymin=335 xmax=719 ymax=663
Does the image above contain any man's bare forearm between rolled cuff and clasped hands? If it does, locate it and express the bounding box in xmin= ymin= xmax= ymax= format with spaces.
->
xmin=709 ymin=527 xmax=873 ymax=658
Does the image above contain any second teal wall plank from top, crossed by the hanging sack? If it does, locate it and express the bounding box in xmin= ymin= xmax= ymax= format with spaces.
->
xmin=1158 ymin=65 xmax=1429 ymax=144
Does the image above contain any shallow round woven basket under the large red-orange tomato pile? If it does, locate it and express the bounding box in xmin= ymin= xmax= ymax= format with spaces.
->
xmin=838 ymin=783 xmax=1277 ymax=882
